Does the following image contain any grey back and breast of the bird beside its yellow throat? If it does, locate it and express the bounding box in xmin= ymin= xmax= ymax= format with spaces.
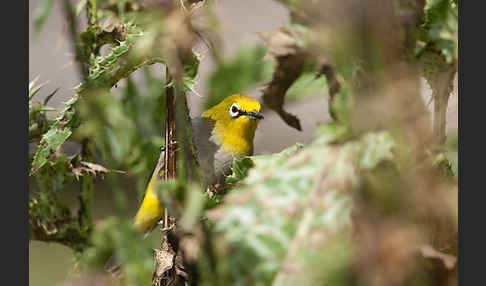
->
xmin=192 ymin=117 xmax=233 ymax=185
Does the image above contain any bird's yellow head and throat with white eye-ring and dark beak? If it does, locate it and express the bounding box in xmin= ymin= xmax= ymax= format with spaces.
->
xmin=202 ymin=94 xmax=263 ymax=154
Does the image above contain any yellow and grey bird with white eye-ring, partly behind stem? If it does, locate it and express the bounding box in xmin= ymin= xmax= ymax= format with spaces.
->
xmin=135 ymin=94 xmax=263 ymax=234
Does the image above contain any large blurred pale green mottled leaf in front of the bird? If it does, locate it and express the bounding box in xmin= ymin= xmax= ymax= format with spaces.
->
xmin=207 ymin=123 xmax=456 ymax=285
